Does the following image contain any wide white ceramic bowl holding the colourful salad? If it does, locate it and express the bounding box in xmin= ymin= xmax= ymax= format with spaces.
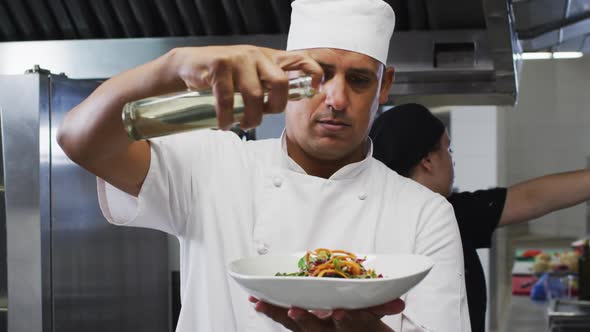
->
xmin=229 ymin=253 xmax=434 ymax=310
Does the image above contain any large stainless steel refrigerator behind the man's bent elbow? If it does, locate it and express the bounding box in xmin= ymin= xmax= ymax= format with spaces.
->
xmin=0 ymin=68 xmax=172 ymax=332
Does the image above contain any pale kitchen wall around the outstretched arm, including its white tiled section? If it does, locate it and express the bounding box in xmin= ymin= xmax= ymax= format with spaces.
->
xmin=448 ymin=57 xmax=590 ymax=331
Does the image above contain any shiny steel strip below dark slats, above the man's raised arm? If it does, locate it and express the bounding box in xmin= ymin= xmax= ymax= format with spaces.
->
xmin=0 ymin=35 xmax=286 ymax=79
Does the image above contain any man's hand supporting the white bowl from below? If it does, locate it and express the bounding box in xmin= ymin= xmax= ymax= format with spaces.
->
xmin=249 ymin=297 xmax=405 ymax=332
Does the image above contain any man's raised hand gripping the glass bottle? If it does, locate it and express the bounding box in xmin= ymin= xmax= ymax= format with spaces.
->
xmin=172 ymin=45 xmax=323 ymax=129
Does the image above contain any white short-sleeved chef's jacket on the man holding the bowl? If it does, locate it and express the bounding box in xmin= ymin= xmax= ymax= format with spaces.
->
xmin=98 ymin=130 xmax=470 ymax=332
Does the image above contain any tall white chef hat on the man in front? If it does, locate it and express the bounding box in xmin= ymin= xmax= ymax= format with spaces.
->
xmin=287 ymin=0 xmax=395 ymax=64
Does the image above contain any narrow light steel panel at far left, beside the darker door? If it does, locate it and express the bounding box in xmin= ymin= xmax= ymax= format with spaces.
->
xmin=0 ymin=75 xmax=50 ymax=332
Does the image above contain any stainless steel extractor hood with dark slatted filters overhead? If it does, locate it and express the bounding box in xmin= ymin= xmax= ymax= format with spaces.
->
xmin=0 ymin=0 xmax=517 ymax=106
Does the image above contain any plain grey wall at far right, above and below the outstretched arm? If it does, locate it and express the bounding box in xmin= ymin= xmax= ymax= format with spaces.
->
xmin=505 ymin=57 xmax=590 ymax=237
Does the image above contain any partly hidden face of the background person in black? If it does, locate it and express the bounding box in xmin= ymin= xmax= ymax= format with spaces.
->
xmin=431 ymin=131 xmax=455 ymax=197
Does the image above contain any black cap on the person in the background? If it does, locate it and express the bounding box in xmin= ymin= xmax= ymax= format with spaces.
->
xmin=369 ymin=104 xmax=445 ymax=177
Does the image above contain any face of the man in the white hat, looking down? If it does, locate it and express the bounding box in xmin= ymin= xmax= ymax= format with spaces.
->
xmin=286 ymin=48 xmax=393 ymax=160
